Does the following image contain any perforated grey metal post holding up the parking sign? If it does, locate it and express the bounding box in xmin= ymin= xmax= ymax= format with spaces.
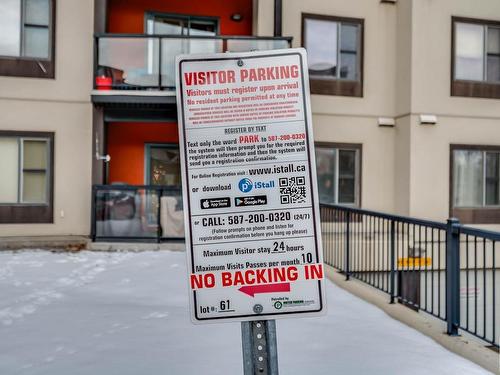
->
xmin=241 ymin=320 xmax=278 ymax=375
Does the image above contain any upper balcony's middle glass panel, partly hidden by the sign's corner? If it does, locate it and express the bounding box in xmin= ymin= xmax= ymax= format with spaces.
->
xmin=161 ymin=38 xmax=223 ymax=88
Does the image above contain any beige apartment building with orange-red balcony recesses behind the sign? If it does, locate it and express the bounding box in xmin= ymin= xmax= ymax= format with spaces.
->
xmin=0 ymin=0 xmax=500 ymax=241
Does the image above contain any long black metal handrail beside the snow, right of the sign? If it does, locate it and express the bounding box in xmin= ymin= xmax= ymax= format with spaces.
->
xmin=320 ymin=204 xmax=500 ymax=348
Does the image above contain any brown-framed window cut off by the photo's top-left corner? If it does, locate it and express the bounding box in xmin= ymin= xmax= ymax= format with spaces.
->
xmin=0 ymin=0 xmax=55 ymax=78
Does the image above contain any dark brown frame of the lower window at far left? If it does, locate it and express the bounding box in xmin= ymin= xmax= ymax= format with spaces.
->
xmin=0 ymin=130 xmax=55 ymax=224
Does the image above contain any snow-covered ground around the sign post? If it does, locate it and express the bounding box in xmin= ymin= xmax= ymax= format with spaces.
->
xmin=0 ymin=251 xmax=487 ymax=375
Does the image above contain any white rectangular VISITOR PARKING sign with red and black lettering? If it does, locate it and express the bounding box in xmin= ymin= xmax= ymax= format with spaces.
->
xmin=178 ymin=49 xmax=325 ymax=323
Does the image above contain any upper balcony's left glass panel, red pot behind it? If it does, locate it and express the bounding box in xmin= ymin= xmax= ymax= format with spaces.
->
xmin=97 ymin=37 xmax=159 ymax=89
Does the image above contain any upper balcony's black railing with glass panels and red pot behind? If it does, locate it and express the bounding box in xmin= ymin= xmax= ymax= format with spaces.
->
xmin=94 ymin=34 xmax=292 ymax=90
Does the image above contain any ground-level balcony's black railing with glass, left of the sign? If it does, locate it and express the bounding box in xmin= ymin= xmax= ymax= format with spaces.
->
xmin=91 ymin=185 xmax=184 ymax=242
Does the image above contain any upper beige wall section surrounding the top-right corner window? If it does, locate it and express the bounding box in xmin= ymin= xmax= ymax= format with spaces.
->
xmin=403 ymin=0 xmax=500 ymax=117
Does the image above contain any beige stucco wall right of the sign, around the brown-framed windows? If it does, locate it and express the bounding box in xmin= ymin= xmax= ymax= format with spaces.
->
xmin=256 ymin=0 xmax=500 ymax=226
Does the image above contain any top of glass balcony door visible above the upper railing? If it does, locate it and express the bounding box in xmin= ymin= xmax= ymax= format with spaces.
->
xmin=146 ymin=12 xmax=219 ymax=36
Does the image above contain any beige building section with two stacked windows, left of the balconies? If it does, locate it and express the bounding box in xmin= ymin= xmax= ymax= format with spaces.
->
xmin=0 ymin=0 xmax=93 ymax=241
